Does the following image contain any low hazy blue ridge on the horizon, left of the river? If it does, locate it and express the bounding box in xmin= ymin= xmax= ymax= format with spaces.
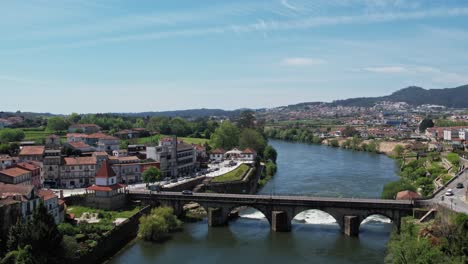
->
xmin=119 ymin=108 xmax=243 ymax=118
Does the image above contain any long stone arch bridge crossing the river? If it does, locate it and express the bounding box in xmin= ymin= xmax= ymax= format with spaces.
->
xmin=127 ymin=190 xmax=422 ymax=236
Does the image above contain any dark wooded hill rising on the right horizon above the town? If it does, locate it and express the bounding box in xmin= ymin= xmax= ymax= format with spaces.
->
xmin=331 ymin=85 xmax=468 ymax=108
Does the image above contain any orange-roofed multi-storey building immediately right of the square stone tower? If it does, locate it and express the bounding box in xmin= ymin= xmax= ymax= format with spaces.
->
xmin=60 ymin=157 xmax=97 ymax=188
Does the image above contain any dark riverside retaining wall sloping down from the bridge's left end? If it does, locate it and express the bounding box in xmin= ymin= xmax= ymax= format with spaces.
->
xmin=76 ymin=206 xmax=151 ymax=264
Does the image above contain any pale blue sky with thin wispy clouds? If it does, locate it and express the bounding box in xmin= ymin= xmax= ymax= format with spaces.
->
xmin=0 ymin=0 xmax=468 ymax=114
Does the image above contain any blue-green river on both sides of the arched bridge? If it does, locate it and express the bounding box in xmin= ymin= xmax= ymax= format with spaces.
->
xmin=109 ymin=140 xmax=398 ymax=264
